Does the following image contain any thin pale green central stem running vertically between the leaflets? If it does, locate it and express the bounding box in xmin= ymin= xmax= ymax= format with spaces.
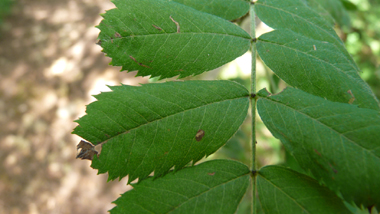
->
xmin=249 ymin=2 xmax=256 ymax=214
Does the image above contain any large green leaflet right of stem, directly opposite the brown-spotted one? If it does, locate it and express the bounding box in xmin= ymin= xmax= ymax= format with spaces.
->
xmin=257 ymin=88 xmax=380 ymax=207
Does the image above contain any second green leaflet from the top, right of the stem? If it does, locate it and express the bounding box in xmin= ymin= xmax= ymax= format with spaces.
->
xmin=257 ymin=30 xmax=379 ymax=110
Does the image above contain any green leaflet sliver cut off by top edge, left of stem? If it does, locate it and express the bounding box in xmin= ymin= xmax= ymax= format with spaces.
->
xmin=174 ymin=0 xmax=249 ymax=20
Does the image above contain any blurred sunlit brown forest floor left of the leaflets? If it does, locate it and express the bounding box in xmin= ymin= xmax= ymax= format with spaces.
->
xmin=0 ymin=0 xmax=147 ymax=214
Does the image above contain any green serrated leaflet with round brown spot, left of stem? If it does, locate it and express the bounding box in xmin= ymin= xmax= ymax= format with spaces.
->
xmin=73 ymin=81 xmax=249 ymax=181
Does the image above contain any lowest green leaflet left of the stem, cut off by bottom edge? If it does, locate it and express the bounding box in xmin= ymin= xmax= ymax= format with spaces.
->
xmin=111 ymin=160 xmax=250 ymax=214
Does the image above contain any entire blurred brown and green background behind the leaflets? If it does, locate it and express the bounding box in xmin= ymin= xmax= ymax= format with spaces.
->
xmin=0 ymin=0 xmax=380 ymax=214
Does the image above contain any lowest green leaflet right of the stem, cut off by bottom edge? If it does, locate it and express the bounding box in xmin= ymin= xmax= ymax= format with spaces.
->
xmin=257 ymin=166 xmax=350 ymax=214
